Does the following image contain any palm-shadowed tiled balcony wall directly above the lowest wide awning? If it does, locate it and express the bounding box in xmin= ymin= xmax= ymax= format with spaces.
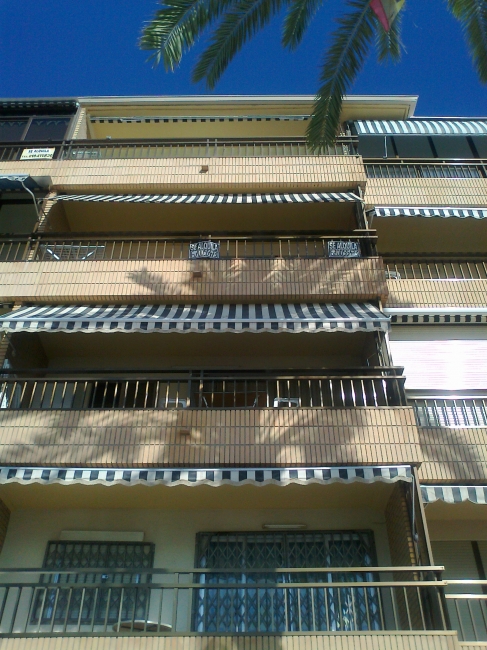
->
xmin=0 ymin=407 xmax=421 ymax=467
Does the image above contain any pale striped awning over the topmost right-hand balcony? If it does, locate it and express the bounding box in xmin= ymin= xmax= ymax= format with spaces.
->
xmin=353 ymin=119 xmax=487 ymax=135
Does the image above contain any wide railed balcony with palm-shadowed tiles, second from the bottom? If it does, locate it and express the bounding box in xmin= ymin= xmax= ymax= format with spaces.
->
xmin=0 ymin=364 xmax=421 ymax=467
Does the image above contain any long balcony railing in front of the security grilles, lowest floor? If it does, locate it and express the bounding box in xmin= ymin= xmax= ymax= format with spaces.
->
xmin=0 ymin=567 xmax=447 ymax=637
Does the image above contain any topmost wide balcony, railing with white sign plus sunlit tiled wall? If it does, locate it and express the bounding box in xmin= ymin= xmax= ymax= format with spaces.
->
xmin=0 ymin=136 xmax=365 ymax=193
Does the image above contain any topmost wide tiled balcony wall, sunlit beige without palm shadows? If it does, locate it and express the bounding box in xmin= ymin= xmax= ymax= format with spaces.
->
xmin=0 ymin=156 xmax=365 ymax=194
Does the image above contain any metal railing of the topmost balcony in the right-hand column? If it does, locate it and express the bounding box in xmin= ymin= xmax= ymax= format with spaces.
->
xmin=365 ymin=160 xmax=487 ymax=178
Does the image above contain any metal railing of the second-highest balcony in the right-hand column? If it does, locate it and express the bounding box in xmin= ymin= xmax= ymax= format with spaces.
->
xmin=384 ymin=255 xmax=487 ymax=280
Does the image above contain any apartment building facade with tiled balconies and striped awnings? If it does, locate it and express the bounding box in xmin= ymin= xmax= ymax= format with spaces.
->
xmin=0 ymin=96 xmax=487 ymax=650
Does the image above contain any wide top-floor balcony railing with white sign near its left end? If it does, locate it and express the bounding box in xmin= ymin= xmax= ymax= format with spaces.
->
xmin=0 ymin=136 xmax=358 ymax=162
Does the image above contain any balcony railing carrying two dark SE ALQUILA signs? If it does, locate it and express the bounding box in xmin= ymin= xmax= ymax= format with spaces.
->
xmin=0 ymin=231 xmax=377 ymax=262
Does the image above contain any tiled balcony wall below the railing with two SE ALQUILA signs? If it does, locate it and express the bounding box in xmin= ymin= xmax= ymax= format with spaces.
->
xmin=0 ymin=258 xmax=387 ymax=303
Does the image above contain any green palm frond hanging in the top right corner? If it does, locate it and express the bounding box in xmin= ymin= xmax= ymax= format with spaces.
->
xmin=448 ymin=0 xmax=487 ymax=83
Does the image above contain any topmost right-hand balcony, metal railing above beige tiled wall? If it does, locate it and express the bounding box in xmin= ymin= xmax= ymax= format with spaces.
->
xmin=365 ymin=159 xmax=487 ymax=206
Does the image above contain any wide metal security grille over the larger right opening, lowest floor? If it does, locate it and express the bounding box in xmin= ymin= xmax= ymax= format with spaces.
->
xmin=193 ymin=531 xmax=381 ymax=633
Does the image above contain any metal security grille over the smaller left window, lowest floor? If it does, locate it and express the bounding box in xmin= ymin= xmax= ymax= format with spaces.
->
xmin=30 ymin=542 xmax=154 ymax=628
